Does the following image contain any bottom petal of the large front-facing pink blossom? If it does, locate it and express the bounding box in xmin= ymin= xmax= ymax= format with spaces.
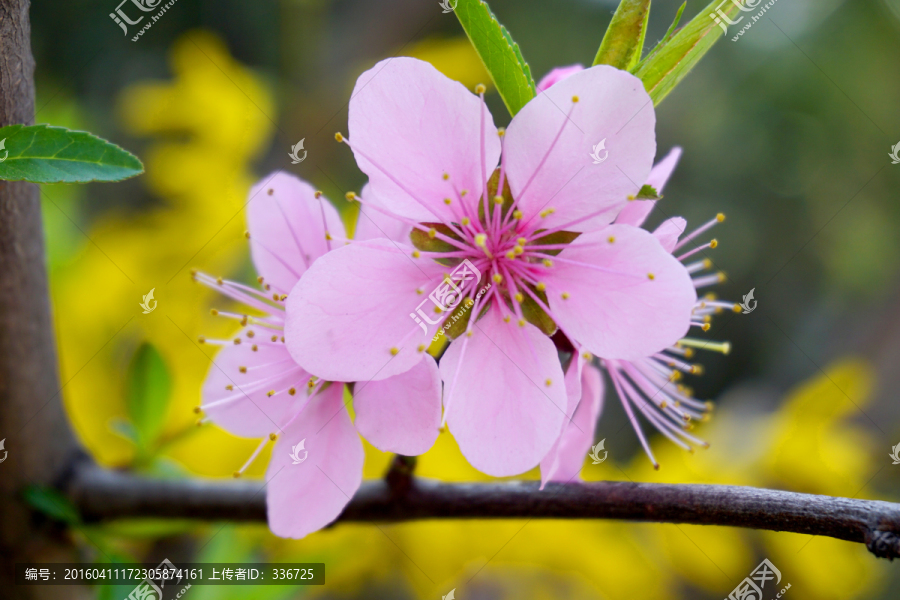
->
xmin=440 ymin=307 xmax=566 ymax=477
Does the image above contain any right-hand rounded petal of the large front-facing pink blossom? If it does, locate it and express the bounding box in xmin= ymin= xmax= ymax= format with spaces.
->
xmin=546 ymin=225 xmax=697 ymax=360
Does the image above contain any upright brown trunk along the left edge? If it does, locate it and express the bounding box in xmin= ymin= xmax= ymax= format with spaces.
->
xmin=0 ymin=0 xmax=85 ymax=599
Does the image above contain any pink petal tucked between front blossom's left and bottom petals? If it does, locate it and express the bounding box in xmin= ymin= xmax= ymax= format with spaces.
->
xmin=353 ymin=355 xmax=441 ymax=456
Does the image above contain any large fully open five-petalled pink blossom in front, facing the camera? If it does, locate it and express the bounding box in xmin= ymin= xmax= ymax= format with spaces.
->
xmin=284 ymin=58 xmax=696 ymax=476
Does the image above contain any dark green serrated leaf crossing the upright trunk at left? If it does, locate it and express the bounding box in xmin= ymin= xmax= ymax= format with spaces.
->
xmin=0 ymin=125 xmax=144 ymax=183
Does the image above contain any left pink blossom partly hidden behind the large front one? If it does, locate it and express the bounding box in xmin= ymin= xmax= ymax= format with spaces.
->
xmin=195 ymin=172 xmax=441 ymax=538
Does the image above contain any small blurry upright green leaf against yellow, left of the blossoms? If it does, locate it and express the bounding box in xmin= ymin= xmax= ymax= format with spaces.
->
xmin=126 ymin=343 xmax=171 ymax=452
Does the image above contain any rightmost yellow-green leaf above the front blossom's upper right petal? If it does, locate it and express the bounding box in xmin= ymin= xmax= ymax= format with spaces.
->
xmin=635 ymin=0 xmax=739 ymax=105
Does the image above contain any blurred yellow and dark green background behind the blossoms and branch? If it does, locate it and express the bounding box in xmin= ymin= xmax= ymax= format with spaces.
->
xmin=32 ymin=0 xmax=900 ymax=600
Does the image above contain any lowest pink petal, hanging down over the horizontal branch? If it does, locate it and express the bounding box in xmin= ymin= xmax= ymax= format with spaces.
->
xmin=266 ymin=383 xmax=365 ymax=538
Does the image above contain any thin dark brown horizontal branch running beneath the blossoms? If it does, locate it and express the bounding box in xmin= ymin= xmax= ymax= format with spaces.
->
xmin=68 ymin=467 xmax=900 ymax=560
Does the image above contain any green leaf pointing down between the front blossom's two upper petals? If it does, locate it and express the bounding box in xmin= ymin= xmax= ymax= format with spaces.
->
xmin=454 ymin=0 xmax=535 ymax=116
